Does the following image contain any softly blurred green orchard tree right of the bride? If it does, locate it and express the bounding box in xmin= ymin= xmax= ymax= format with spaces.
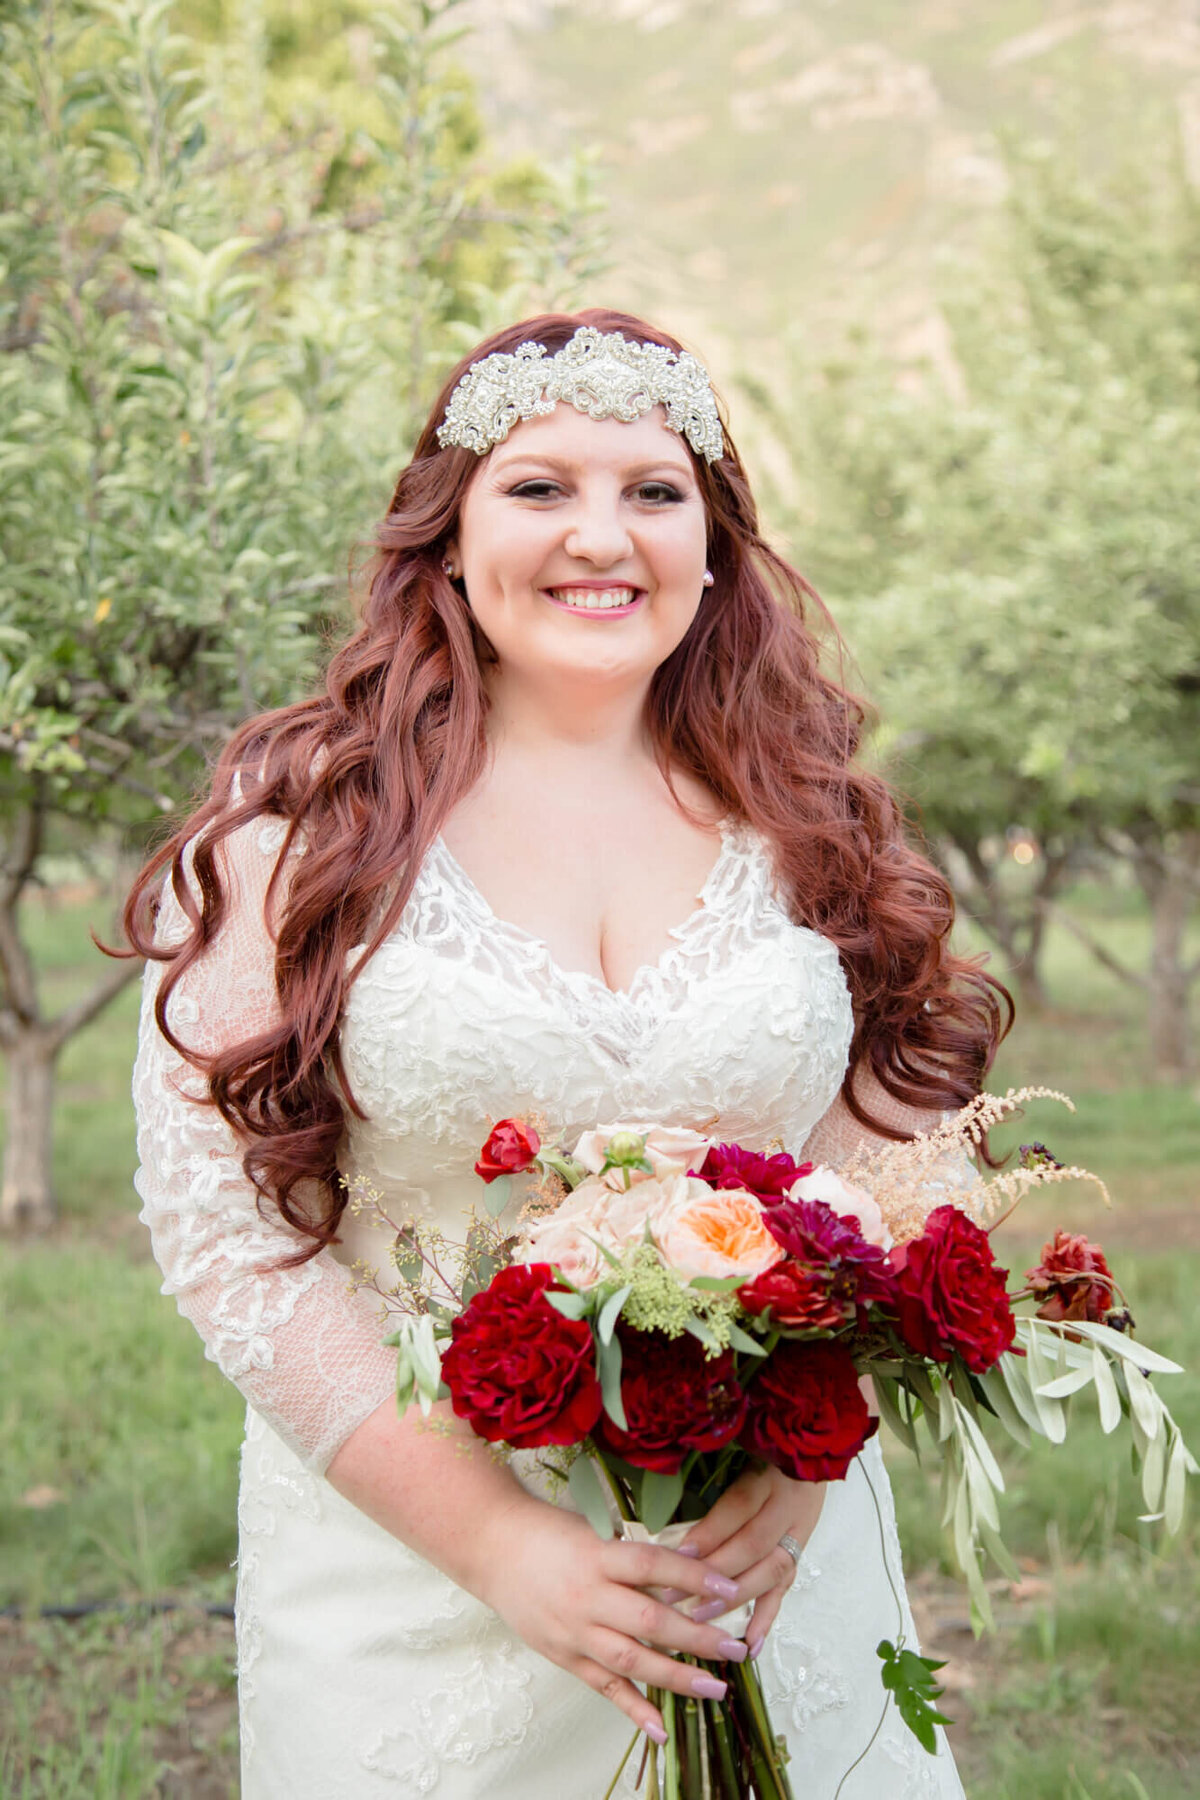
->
xmin=766 ymin=146 xmax=1200 ymax=1078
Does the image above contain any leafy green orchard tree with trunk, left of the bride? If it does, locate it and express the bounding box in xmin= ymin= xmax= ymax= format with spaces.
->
xmin=0 ymin=0 xmax=611 ymax=1224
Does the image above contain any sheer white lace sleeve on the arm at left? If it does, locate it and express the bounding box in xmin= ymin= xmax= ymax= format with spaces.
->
xmin=133 ymin=821 xmax=396 ymax=1471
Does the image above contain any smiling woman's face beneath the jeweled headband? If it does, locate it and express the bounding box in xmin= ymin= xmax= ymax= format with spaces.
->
xmin=450 ymin=403 xmax=707 ymax=689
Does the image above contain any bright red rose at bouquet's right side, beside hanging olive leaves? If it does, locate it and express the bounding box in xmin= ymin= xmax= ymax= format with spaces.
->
xmin=892 ymin=1206 xmax=1016 ymax=1375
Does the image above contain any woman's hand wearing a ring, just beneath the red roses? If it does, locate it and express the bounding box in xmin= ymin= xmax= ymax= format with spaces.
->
xmin=685 ymin=1463 xmax=826 ymax=1656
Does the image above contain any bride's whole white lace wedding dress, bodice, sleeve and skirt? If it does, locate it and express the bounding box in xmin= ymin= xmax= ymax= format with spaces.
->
xmin=135 ymin=821 xmax=963 ymax=1800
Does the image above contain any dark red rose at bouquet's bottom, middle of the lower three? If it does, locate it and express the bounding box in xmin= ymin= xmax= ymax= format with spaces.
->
xmin=596 ymin=1327 xmax=747 ymax=1474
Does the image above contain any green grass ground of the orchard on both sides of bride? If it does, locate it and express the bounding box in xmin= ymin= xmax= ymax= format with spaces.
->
xmin=0 ymin=893 xmax=1200 ymax=1800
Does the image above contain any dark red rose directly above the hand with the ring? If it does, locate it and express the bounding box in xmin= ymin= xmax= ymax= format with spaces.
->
xmin=741 ymin=1337 xmax=880 ymax=1481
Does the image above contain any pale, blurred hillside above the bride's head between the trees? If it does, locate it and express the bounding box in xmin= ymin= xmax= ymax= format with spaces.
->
xmin=468 ymin=0 xmax=1200 ymax=369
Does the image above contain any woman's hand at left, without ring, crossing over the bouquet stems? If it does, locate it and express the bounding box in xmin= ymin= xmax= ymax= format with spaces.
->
xmin=471 ymin=1498 xmax=747 ymax=1744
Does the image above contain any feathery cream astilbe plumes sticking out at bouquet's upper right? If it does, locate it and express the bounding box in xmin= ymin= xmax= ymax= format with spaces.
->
xmin=838 ymin=1087 xmax=1112 ymax=1244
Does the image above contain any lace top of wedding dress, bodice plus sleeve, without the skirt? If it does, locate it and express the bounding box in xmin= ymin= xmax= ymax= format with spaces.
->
xmin=135 ymin=821 xmax=921 ymax=1469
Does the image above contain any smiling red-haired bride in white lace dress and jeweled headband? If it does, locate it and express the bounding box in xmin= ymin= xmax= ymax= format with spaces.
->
xmin=128 ymin=311 xmax=1000 ymax=1800
